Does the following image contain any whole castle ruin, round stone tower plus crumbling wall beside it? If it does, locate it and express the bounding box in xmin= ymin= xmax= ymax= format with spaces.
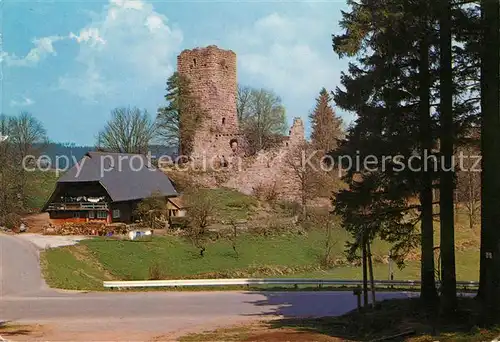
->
xmin=177 ymin=45 xmax=305 ymax=200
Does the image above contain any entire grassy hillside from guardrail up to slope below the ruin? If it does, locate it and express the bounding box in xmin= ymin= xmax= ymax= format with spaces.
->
xmin=37 ymin=188 xmax=479 ymax=289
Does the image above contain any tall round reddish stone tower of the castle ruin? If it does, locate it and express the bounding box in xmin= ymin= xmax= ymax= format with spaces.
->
xmin=177 ymin=45 xmax=242 ymax=166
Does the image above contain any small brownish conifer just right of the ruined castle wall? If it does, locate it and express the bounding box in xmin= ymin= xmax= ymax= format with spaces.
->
xmin=309 ymin=88 xmax=343 ymax=153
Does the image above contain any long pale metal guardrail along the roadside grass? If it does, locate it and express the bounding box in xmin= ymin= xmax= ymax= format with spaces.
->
xmin=103 ymin=278 xmax=479 ymax=290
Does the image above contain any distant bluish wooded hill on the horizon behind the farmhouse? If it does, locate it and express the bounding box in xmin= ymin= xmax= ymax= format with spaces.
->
xmin=35 ymin=143 xmax=177 ymax=169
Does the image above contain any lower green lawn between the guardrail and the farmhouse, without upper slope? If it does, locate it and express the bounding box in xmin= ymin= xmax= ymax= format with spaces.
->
xmin=42 ymin=226 xmax=479 ymax=289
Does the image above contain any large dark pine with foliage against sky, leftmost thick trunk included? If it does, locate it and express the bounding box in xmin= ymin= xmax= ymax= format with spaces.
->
xmin=334 ymin=0 xmax=437 ymax=308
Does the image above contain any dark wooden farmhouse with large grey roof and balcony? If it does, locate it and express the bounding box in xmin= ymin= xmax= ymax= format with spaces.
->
xmin=43 ymin=152 xmax=178 ymax=225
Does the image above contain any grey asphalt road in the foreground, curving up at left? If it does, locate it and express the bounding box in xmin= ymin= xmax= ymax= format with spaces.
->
xmin=0 ymin=234 xmax=411 ymax=338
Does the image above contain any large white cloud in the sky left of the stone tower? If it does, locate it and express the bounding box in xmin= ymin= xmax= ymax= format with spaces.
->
xmin=59 ymin=0 xmax=182 ymax=101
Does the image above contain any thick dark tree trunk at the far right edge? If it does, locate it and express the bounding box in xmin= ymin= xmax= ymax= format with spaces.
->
xmin=478 ymin=0 xmax=500 ymax=324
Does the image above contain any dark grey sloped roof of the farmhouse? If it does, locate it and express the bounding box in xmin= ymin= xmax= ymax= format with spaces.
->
xmin=58 ymin=152 xmax=178 ymax=202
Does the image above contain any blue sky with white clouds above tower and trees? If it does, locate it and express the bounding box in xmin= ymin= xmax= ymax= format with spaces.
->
xmin=0 ymin=0 xmax=353 ymax=145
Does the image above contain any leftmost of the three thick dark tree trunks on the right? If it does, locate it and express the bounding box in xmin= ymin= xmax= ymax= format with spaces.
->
xmin=419 ymin=28 xmax=437 ymax=308
